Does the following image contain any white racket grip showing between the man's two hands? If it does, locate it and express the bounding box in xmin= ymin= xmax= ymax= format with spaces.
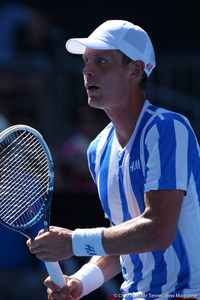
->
xmin=45 ymin=262 xmax=66 ymax=288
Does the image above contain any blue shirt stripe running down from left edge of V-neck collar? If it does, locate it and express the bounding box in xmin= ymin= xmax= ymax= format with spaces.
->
xmin=99 ymin=127 xmax=114 ymax=220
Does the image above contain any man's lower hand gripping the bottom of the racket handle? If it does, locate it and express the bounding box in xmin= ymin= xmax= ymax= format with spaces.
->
xmin=44 ymin=275 xmax=82 ymax=300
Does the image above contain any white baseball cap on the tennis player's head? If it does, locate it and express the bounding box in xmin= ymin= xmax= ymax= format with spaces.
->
xmin=66 ymin=20 xmax=156 ymax=76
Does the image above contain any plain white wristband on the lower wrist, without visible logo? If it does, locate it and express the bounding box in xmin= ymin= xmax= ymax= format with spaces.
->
xmin=70 ymin=263 xmax=104 ymax=299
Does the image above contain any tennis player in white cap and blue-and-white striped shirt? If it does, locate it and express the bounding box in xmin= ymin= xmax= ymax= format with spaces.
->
xmin=28 ymin=20 xmax=200 ymax=299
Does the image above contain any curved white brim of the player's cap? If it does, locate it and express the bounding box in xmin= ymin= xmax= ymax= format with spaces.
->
xmin=65 ymin=38 xmax=117 ymax=54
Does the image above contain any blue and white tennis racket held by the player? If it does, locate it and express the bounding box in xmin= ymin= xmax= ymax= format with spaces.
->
xmin=0 ymin=125 xmax=65 ymax=288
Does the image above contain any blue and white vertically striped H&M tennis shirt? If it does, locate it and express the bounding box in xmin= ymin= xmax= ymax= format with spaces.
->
xmin=88 ymin=100 xmax=200 ymax=300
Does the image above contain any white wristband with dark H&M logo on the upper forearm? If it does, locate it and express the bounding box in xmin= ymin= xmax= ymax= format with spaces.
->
xmin=72 ymin=227 xmax=107 ymax=256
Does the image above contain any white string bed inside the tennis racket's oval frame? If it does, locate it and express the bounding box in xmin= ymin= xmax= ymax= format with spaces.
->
xmin=0 ymin=132 xmax=49 ymax=226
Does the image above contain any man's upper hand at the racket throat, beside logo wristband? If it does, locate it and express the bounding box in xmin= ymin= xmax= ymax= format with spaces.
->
xmin=27 ymin=226 xmax=73 ymax=262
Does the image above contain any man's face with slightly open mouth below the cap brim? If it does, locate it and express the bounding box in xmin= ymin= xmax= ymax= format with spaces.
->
xmin=83 ymin=48 xmax=130 ymax=112
